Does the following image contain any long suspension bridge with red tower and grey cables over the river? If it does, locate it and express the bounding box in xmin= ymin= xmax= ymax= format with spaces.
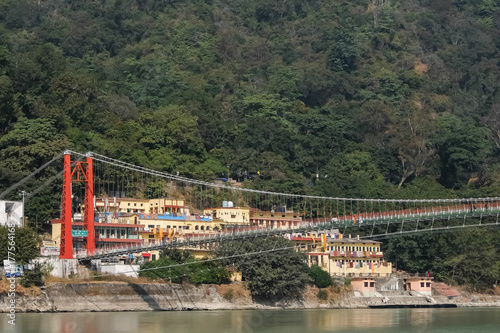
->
xmin=0 ymin=150 xmax=500 ymax=262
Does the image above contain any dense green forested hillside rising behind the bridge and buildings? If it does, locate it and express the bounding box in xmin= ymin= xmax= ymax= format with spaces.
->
xmin=0 ymin=0 xmax=500 ymax=281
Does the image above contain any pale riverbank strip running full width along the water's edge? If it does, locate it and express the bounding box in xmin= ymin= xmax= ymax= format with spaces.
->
xmin=0 ymin=281 xmax=500 ymax=312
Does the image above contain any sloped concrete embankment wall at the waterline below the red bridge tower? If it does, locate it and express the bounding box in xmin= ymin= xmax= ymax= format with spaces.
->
xmin=0 ymin=282 xmax=244 ymax=312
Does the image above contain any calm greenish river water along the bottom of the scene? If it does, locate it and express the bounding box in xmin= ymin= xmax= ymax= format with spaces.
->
xmin=0 ymin=308 xmax=500 ymax=333
